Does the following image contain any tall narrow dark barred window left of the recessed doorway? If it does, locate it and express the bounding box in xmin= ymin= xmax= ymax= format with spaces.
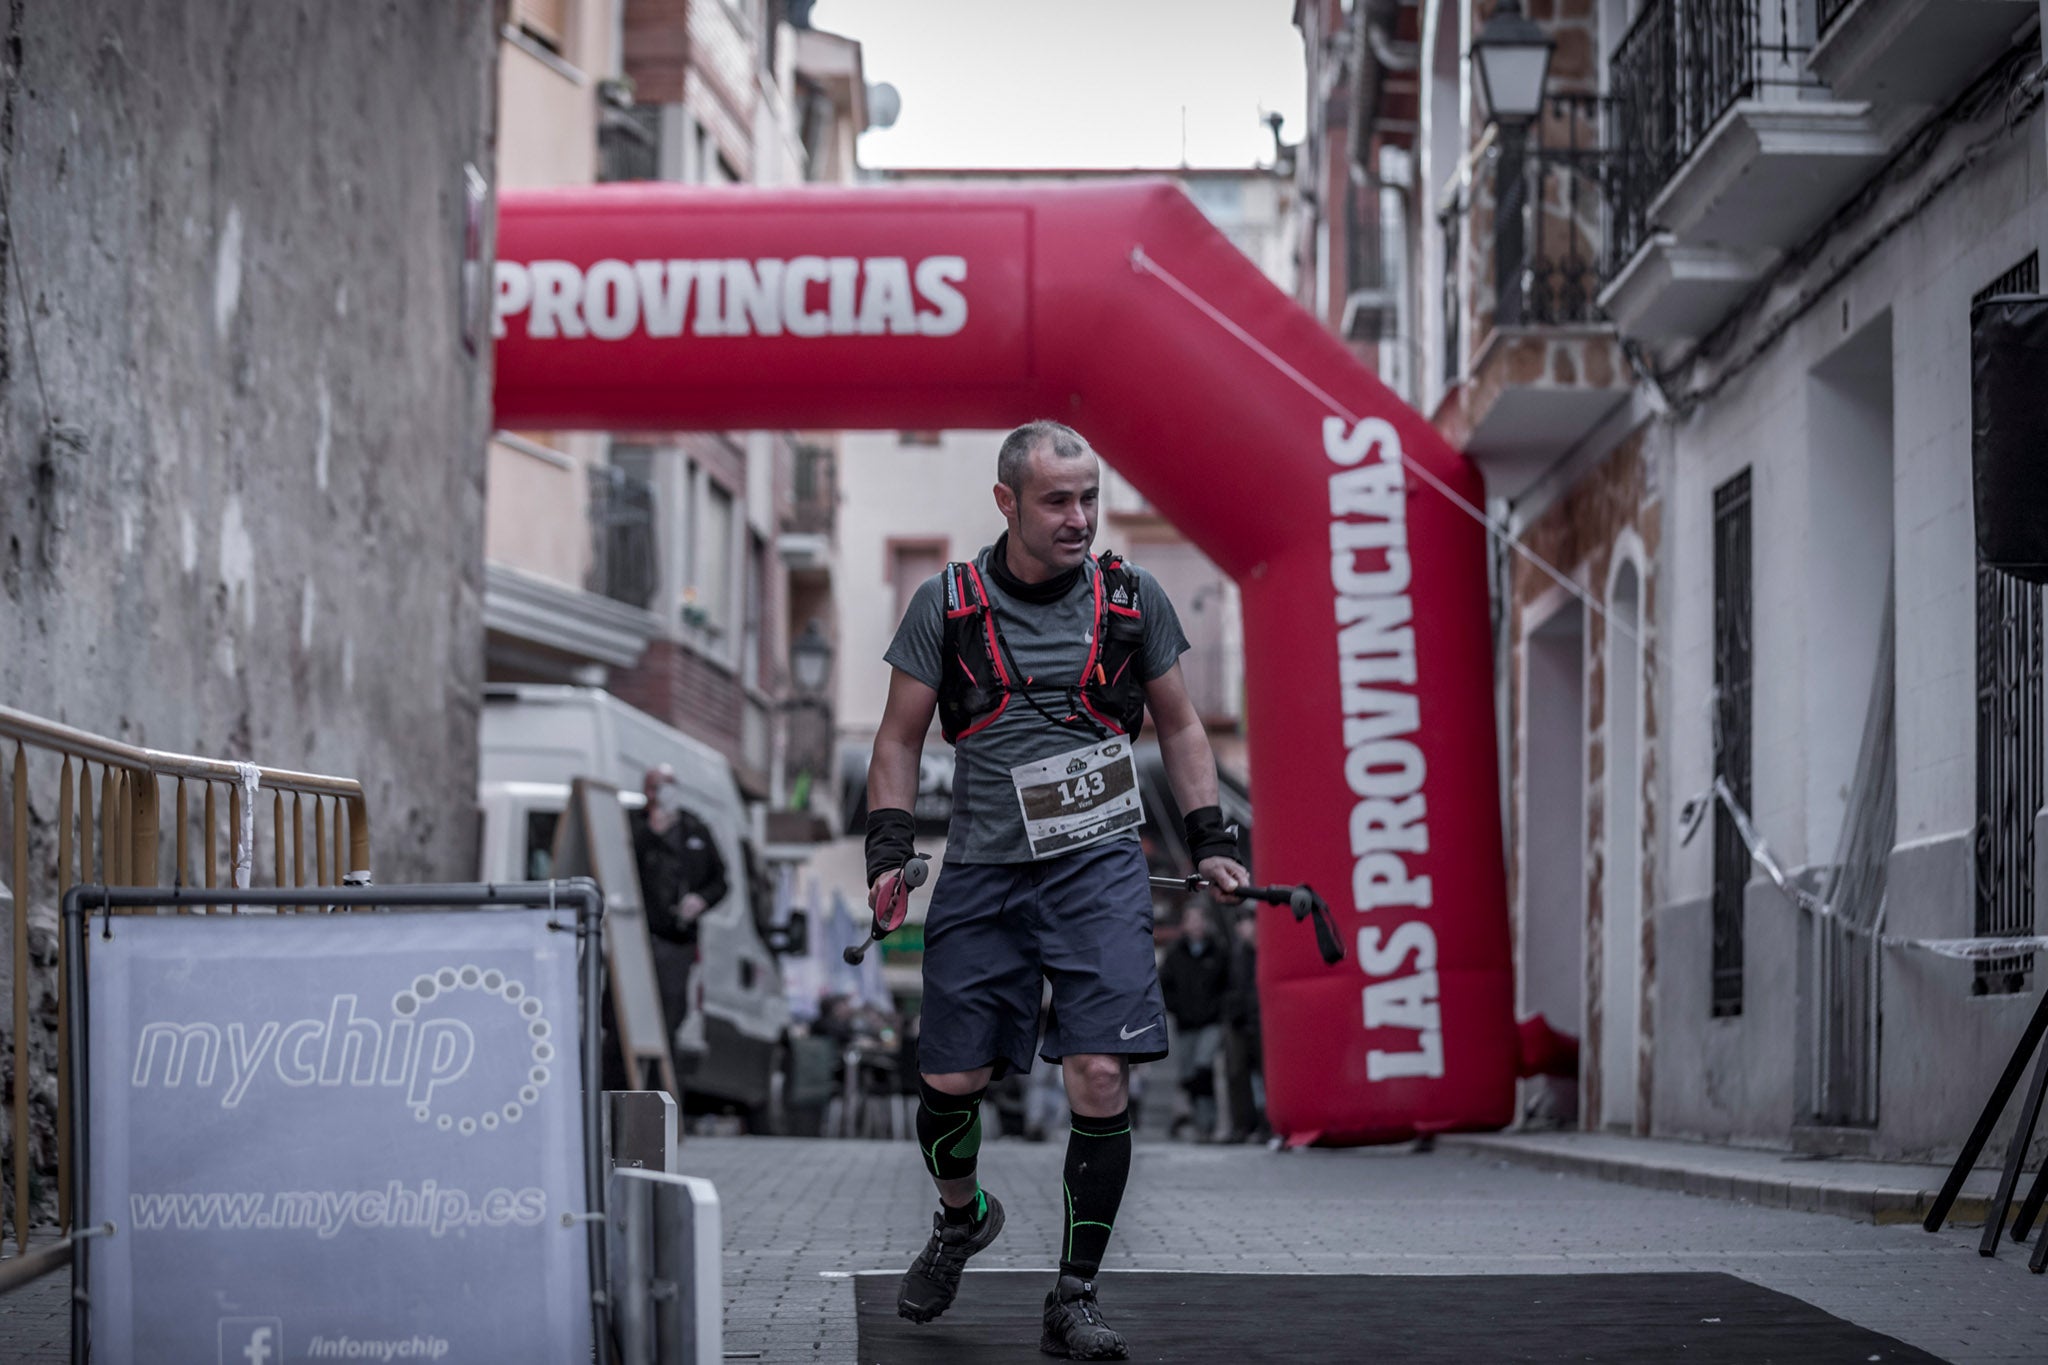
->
xmin=1712 ymin=469 xmax=1751 ymax=1019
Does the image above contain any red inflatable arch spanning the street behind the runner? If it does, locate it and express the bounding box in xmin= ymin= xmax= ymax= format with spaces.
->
xmin=496 ymin=182 xmax=1516 ymax=1142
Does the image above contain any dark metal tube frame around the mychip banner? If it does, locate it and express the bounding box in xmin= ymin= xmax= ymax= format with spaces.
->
xmin=53 ymin=878 xmax=610 ymax=1365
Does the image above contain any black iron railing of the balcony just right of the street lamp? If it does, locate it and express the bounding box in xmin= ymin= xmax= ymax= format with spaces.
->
xmin=1606 ymin=0 xmax=1825 ymax=278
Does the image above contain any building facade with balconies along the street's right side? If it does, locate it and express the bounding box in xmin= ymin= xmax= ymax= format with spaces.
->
xmin=1298 ymin=0 xmax=2048 ymax=1156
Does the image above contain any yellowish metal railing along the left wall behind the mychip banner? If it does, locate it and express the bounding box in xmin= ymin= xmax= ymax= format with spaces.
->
xmin=0 ymin=706 xmax=371 ymax=1268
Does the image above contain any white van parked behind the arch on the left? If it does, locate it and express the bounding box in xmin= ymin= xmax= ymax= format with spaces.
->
xmin=477 ymin=684 xmax=788 ymax=1132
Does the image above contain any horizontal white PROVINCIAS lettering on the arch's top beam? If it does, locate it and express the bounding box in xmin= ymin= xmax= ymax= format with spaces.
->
xmin=492 ymin=256 xmax=974 ymax=341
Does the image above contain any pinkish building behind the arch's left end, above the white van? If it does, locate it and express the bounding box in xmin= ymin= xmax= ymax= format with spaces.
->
xmin=487 ymin=0 xmax=866 ymax=822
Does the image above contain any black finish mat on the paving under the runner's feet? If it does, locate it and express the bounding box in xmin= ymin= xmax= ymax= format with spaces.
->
xmin=854 ymin=1271 xmax=1942 ymax=1365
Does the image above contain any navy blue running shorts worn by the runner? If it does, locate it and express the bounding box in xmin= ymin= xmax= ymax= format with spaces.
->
xmin=918 ymin=841 xmax=1165 ymax=1076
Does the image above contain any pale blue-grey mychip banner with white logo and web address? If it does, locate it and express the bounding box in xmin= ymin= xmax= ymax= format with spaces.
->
xmin=88 ymin=909 xmax=590 ymax=1365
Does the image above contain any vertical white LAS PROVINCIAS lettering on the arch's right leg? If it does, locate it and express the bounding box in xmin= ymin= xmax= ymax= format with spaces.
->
xmin=1323 ymin=417 xmax=1444 ymax=1081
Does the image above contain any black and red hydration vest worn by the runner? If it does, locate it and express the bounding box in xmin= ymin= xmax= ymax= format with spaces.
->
xmin=938 ymin=551 xmax=1145 ymax=745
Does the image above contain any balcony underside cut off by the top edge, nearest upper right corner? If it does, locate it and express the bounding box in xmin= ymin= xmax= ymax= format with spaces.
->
xmin=1806 ymin=0 xmax=2038 ymax=104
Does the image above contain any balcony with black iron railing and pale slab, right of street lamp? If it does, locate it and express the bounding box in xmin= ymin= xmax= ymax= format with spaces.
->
xmin=1599 ymin=0 xmax=1909 ymax=346
